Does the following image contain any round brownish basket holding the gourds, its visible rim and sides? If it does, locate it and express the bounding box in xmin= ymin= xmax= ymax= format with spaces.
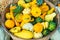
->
xmin=1 ymin=0 xmax=59 ymax=40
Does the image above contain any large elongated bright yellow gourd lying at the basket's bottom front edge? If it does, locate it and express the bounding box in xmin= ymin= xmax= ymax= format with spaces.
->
xmin=14 ymin=30 xmax=33 ymax=39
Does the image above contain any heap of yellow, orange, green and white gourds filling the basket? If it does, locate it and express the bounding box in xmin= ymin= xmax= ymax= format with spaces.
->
xmin=5 ymin=0 xmax=57 ymax=39
